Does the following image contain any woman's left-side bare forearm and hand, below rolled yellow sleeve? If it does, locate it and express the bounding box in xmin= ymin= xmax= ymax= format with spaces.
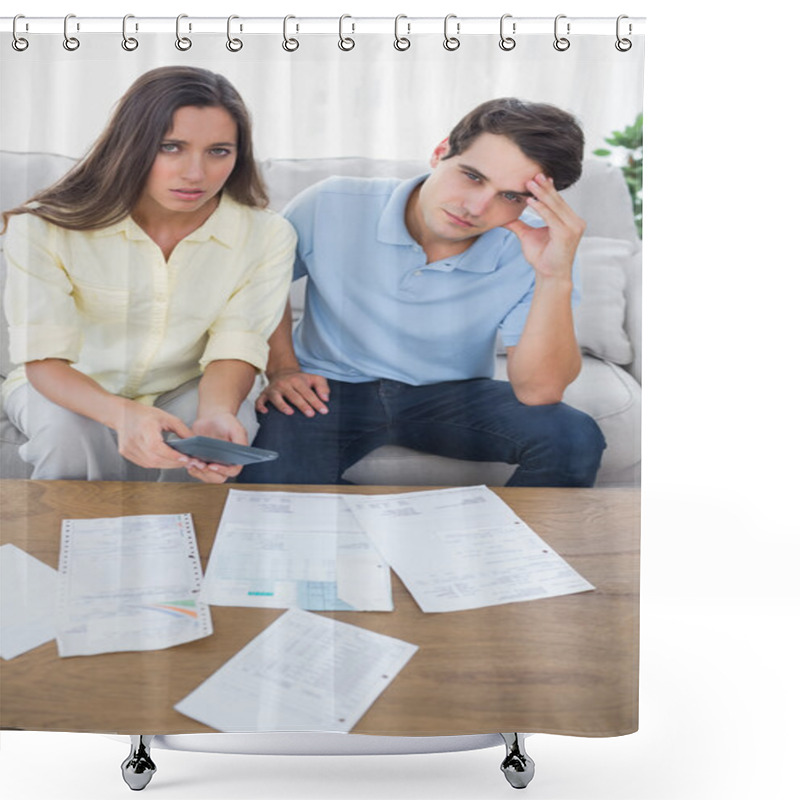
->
xmin=25 ymin=358 xmax=192 ymax=469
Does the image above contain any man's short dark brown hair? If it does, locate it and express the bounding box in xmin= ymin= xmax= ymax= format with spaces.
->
xmin=444 ymin=97 xmax=584 ymax=190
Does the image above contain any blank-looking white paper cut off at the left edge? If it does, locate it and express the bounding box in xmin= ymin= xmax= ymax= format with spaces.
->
xmin=0 ymin=544 xmax=58 ymax=658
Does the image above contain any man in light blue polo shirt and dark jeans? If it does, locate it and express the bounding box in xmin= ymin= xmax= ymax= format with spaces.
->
xmin=239 ymin=98 xmax=605 ymax=486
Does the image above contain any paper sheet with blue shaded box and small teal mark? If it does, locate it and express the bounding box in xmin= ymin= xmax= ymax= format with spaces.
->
xmin=201 ymin=489 xmax=393 ymax=611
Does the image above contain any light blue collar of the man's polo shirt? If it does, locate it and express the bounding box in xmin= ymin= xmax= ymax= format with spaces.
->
xmin=378 ymin=173 xmax=514 ymax=272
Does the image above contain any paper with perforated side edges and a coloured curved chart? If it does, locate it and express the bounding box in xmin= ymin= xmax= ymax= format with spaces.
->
xmin=57 ymin=514 xmax=212 ymax=656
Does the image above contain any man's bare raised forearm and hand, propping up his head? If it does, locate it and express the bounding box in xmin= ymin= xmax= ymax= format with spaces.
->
xmin=505 ymin=175 xmax=586 ymax=406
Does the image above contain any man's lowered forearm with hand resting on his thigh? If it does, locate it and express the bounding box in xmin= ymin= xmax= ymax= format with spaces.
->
xmin=256 ymin=303 xmax=330 ymax=417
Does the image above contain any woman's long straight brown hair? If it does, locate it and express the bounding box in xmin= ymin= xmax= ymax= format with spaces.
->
xmin=3 ymin=67 xmax=269 ymax=230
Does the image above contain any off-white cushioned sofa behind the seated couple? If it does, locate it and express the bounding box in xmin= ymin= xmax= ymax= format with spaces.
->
xmin=0 ymin=152 xmax=642 ymax=486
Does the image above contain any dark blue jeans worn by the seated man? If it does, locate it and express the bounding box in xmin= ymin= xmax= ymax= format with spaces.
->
xmin=238 ymin=378 xmax=605 ymax=486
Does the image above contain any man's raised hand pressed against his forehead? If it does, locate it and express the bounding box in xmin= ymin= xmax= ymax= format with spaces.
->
xmin=503 ymin=174 xmax=586 ymax=281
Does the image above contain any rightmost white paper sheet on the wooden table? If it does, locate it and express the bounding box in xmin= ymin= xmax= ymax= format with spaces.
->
xmin=346 ymin=486 xmax=594 ymax=611
